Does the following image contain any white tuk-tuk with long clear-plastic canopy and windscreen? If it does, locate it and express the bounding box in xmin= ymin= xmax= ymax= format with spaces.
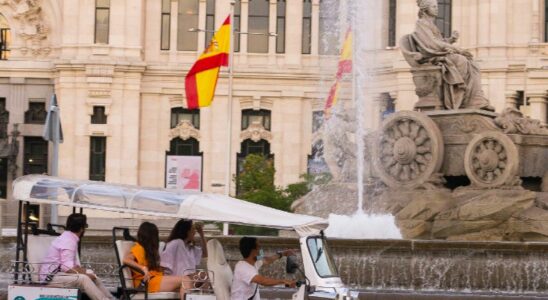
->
xmin=8 ymin=175 xmax=357 ymax=300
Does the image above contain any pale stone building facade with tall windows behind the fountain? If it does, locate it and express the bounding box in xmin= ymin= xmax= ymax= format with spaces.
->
xmin=0 ymin=0 xmax=548 ymax=230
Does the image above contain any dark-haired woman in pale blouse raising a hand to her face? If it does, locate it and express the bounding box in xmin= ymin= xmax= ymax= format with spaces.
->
xmin=161 ymin=219 xmax=207 ymax=276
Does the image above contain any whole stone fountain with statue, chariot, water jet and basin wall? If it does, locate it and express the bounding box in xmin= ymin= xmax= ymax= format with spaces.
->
xmin=292 ymin=0 xmax=548 ymax=299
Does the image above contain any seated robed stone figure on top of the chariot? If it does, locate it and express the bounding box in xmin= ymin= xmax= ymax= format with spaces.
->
xmin=411 ymin=0 xmax=492 ymax=110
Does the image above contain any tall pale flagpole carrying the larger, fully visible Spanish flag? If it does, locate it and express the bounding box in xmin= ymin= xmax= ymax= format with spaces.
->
xmin=223 ymin=0 xmax=236 ymax=235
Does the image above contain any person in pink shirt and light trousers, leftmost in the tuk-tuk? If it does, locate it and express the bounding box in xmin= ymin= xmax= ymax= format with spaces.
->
xmin=40 ymin=213 xmax=114 ymax=300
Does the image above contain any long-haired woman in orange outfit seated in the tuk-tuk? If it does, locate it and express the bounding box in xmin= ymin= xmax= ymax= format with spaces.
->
xmin=124 ymin=222 xmax=190 ymax=299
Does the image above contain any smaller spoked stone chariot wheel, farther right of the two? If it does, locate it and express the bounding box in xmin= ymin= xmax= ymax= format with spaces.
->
xmin=464 ymin=131 xmax=519 ymax=188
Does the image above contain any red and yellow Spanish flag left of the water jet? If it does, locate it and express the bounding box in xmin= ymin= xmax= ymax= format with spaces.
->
xmin=185 ymin=16 xmax=230 ymax=109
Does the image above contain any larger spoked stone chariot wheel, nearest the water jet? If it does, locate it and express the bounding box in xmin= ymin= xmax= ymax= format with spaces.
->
xmin=373 ymin=111 xmax=443 ymax=188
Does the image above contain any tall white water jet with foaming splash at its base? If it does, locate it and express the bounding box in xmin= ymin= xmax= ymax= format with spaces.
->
xmin=323 ymin=0 xmax=402 ymax=239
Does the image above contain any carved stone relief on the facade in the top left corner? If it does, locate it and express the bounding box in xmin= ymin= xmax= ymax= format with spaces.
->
xmin=0 ymin=0 xmax=51 ymax=56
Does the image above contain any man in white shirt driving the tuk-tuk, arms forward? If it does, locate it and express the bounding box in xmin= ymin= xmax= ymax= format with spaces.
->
xmin=230 ymin=237 xmax=295 ymax=300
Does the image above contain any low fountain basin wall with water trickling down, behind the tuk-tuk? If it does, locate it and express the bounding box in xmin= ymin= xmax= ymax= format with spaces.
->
xmin=0 ymin=237 xmax=548 ymax=299
